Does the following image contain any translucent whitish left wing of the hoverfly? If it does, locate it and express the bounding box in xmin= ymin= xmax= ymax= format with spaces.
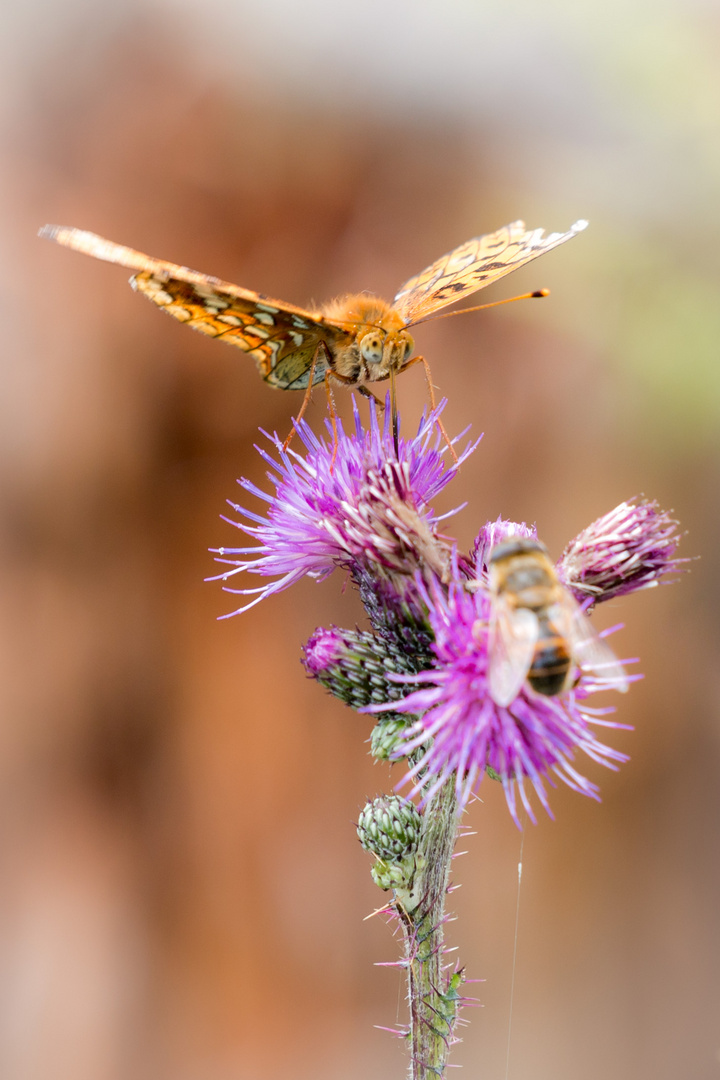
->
xmin=488 ymin=598 xmax=540 ymax=706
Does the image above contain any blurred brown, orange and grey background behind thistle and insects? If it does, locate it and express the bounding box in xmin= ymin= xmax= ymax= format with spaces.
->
xmin=0 ymin=0 xmax=720 ymax=1080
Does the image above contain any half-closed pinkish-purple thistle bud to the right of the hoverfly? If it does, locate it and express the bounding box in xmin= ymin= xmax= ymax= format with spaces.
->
xmin=557 ymin=500 xmax=687 ymax=603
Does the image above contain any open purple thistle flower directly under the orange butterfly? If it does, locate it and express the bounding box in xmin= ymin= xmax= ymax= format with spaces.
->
xmin=211 ymin=403 xmax=479 ymax=615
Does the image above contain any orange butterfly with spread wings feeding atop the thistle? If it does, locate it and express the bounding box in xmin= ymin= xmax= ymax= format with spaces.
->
xmin=39 ymin=220 xmax=587 ymax=442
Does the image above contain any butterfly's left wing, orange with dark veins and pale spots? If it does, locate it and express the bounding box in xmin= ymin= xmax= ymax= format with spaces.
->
xmin=40 ymin=225 xmax=350 ymax=390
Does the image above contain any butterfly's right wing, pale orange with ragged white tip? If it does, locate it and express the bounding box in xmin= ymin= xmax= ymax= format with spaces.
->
xmin=393 ymin=221 xmax=587 ymax=326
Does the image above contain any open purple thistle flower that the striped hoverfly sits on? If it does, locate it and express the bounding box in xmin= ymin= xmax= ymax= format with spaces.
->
xmin=366 ymin=582 xmax=627 ymax=825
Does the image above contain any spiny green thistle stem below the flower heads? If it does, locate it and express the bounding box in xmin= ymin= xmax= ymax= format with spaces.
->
xmin=397 ymin=773 xmax=462 ymax=1080
